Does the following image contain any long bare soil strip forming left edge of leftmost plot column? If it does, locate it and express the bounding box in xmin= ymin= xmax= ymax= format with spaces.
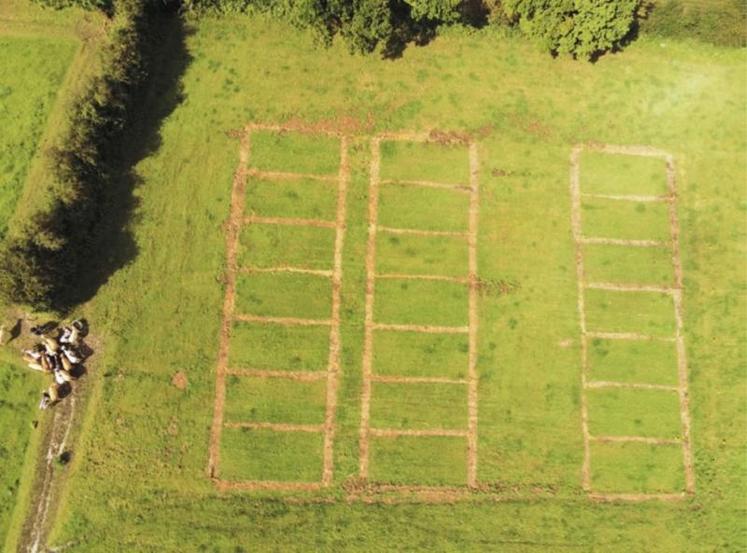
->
xmin=208 ymin=129 xmax=251 ymax=478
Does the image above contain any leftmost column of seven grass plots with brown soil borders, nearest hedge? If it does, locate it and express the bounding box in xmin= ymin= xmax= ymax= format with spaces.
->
xmin=208 ymin=124 xmax=349 ymax=491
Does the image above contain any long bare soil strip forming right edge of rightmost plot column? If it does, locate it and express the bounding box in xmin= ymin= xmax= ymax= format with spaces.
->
xmin=666 ymin=156 xmax=695 ymax=494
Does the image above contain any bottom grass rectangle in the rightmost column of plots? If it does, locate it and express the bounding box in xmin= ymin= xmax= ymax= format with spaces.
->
xmin=591 ymin=443 xmax=685 ymax=493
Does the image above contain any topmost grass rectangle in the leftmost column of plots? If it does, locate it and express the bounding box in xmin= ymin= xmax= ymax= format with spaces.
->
xmin=249 ymin=130 xmax=340 ymax=176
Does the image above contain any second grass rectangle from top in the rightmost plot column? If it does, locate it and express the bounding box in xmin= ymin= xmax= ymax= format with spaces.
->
xmin=581 ymin=198 xmax=671 ymax=242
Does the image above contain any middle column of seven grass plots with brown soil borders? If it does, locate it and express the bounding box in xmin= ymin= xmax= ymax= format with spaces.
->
xmin=359 ymin=133 xmax=479 ymax=492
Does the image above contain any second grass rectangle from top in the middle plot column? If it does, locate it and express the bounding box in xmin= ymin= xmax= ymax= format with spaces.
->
xmin=378 ymin=185 xmax=469 ymax=232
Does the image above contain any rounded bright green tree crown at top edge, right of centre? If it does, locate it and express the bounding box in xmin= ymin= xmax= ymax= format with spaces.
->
xmin=502 ymin=0 xmax=640 ymax=59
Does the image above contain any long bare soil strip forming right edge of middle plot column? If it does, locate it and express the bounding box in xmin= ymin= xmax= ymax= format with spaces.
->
xmin=467 ymin=142 xmax=480 ymax=488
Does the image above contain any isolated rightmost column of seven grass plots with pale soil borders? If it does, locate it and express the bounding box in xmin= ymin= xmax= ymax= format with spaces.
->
xmin=570 ymin=145 xmax=695 ymax=501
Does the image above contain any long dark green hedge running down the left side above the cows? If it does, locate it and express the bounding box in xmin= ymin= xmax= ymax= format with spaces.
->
xmin=0 ymin=0 xmax=147 ymax=310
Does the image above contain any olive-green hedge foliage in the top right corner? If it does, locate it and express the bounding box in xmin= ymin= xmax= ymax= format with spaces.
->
xmin=641 ymin=0 xmax=747 ymax=46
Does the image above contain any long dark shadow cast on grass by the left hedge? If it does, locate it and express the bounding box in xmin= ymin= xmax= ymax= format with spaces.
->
xmin=55 ymin=11 xmax=192 ymax=312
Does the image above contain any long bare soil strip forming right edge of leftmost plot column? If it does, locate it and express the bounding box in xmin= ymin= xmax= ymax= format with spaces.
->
xmin=322 ymin=136 xmax=350 ymax=486
